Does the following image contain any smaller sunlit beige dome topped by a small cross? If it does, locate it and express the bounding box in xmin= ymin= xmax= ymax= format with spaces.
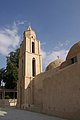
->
xmin=46 ymin=59 xmax=64 ymax=71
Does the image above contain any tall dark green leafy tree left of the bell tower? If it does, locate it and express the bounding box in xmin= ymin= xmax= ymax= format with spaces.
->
xmin=5 ymin=48 xmax=20 ymax=89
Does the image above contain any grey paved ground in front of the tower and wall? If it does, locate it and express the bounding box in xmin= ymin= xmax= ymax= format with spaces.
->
xmin=0 ymin=107 xmax=66 ymax=120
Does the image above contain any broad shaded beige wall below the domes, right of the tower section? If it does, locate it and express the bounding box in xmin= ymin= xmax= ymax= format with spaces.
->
xmin=43 ymin=62 xmax=80 ymax=118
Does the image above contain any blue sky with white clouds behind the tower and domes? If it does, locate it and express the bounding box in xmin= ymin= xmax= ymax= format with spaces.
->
xmin=0 ymin=0 xmax=80 ymax=69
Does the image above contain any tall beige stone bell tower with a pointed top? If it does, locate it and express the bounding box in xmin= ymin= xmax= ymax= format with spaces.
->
xmin=18 ymin=26 xmax=42 ymax=108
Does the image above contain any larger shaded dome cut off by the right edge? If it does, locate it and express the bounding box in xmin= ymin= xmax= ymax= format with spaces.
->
xmin=66 ymin=41 xmax=80 ymax=60
